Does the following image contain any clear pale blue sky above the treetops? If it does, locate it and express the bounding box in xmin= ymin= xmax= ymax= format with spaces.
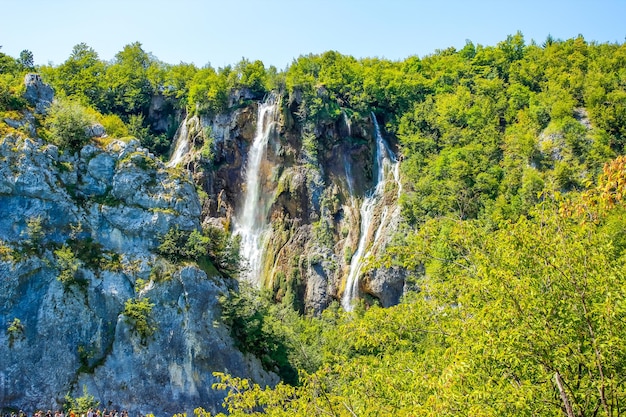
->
xmin=0 ymin=0 xmax=626 ymax=69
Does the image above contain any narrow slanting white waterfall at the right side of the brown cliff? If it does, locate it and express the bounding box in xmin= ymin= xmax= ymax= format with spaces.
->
xmin=341 ymin=114 xmax=400 ymax=311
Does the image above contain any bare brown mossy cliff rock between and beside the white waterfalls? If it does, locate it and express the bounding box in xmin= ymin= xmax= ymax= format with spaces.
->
xmin=171 ymin=91 xmax=404 ymax=314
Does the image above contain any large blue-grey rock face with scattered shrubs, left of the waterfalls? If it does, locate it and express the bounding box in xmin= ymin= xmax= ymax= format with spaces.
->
xmin=0 ymin=137 xmax=276 ymax=416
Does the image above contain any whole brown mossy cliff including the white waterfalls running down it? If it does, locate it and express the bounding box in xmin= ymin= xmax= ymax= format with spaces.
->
xmin=170 ymin=94 xmax=405 ymax=314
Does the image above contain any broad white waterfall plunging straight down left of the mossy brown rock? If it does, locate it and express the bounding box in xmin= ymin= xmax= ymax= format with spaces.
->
xmin=235 ymin=95 xmax=278 ymax=282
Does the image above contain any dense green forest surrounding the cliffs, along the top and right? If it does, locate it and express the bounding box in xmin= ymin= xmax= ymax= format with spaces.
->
xmin=0 ymin=33 xmax=626 ymax=417
